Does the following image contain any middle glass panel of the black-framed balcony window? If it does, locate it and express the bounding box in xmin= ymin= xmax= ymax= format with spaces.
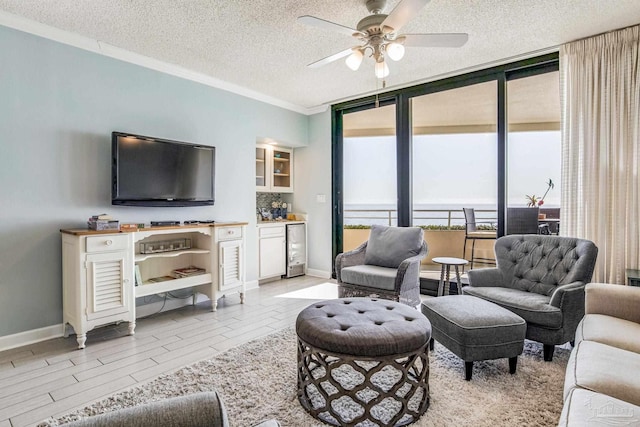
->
xmin=411 ymin=80 xmax=498 ymax=267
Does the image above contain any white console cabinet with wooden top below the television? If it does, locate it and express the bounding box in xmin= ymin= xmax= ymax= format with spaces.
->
xmin=61 ymin=223 xmax=246 ymax=348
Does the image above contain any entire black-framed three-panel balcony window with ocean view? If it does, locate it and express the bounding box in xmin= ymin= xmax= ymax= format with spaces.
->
xmin=332 ymin=54 xmax=560 ymax=270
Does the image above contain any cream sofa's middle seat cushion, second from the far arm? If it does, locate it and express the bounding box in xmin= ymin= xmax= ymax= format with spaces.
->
xmin=564 ymin=341 xmax=640 ymax=405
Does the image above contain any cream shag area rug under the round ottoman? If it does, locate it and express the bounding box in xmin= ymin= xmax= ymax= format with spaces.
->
xmin=40 ymin=328 xmax=569 ymax=427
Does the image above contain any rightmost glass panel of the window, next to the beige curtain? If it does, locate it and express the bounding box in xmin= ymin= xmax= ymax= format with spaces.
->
xmin=506 ymin=71 xmax=561 ymax=234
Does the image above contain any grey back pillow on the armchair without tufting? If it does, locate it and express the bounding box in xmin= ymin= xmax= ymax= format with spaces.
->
xmin=362 ymin=225 xmax=423 ymax=268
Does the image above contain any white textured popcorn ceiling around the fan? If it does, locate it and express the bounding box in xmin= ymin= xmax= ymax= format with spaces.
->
xmin=0 ymin=0 xmax=640 ymax=111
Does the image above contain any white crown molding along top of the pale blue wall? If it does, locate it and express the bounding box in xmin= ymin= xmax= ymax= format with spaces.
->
xmin=0 ymin=10 xmax=328 ymax=116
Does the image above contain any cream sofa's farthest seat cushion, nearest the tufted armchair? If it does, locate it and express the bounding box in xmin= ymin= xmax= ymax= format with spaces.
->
xmin=576 ymin=314 xmax=640 ymax=353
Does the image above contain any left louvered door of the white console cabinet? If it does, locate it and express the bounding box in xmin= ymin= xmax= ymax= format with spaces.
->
xmin=86 ymin=251 xmax=133 ymax=320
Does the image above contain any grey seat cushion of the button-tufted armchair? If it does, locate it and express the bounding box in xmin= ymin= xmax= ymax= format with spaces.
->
xmin=462 ymin=286 xmax=562 ymax=329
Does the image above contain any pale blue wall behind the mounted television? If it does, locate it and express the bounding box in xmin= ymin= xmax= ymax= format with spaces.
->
xmin=0 ymin=26 xmax=309 ymax=336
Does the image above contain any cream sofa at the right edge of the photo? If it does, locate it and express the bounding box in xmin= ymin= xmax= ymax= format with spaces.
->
xmin=559 ymin=283 xmax=640 ymax=426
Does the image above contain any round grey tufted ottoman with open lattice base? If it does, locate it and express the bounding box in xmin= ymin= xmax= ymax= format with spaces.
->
xmin=296 ymin=298 xmax=431 ymax=426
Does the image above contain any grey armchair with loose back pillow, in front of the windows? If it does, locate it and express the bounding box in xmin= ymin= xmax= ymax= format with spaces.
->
xmin=336 ymin=225 xmax=427 ymax=307
